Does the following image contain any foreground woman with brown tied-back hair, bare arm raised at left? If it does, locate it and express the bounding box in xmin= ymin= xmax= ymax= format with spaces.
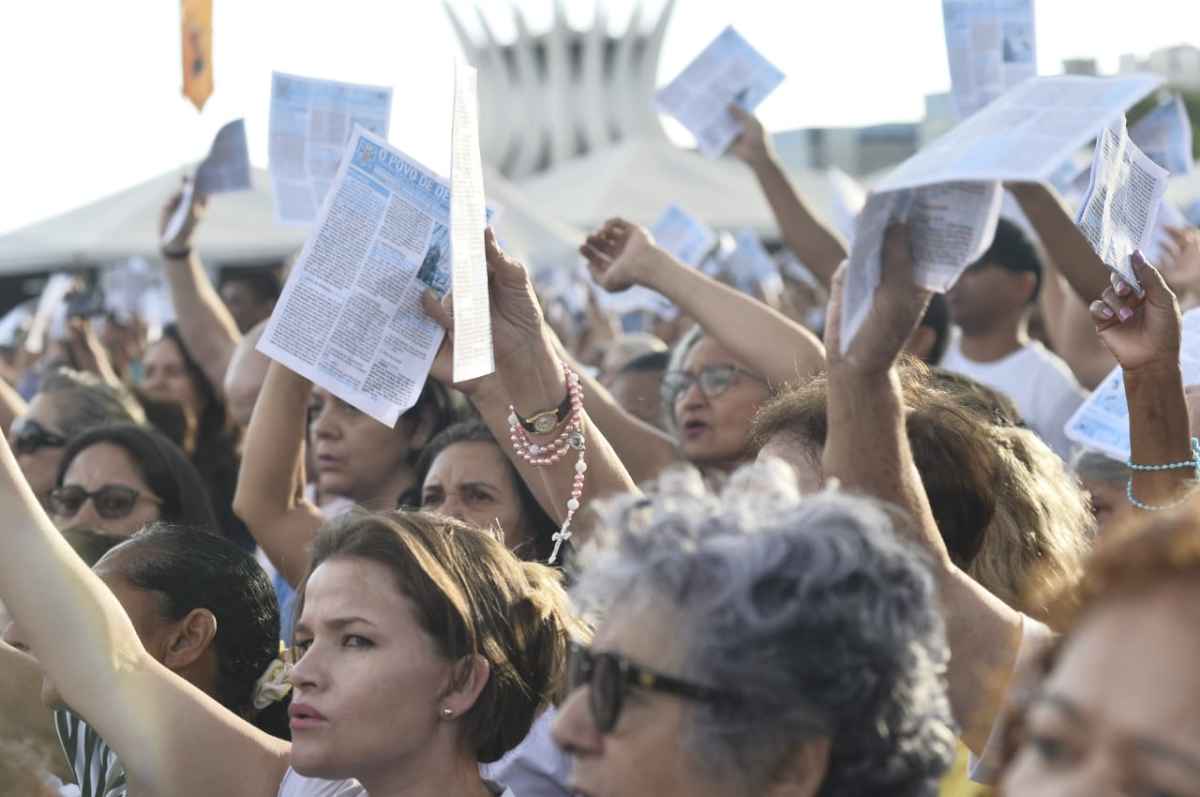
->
xmin=0 ymin=410 xmax=586 ymax=797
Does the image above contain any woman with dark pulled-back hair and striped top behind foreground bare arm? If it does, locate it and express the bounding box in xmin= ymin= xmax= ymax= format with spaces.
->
xmin=0 ymin=523 xmax=288 ymax=797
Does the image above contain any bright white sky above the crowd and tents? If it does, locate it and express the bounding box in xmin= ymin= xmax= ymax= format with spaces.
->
xmin=0 ymin=0 xmax=1200 ymax=232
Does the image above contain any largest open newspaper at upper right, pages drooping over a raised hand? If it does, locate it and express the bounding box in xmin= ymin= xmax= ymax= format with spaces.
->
xmin=841 ymin=74 xmax=1162 ymax=347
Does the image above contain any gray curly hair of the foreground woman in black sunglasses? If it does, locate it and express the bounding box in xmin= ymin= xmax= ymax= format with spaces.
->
xmin=572 ymin=462 xmax=955 ymax=797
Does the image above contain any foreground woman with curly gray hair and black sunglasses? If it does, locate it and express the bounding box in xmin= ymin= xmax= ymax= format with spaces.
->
xmin=554 ymin=465 xmax=954 ymax=797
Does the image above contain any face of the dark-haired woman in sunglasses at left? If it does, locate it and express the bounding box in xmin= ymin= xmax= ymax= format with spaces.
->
xmin=50 ymin=443 xmax=161 ymax=537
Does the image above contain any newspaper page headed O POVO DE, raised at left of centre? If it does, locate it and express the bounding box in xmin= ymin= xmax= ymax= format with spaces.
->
xmin=258 ymin=127 xmax=463 ymax=426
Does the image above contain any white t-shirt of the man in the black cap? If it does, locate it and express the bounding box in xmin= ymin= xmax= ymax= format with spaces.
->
xmin=941 ymin=330 xmax=1087 ymax=460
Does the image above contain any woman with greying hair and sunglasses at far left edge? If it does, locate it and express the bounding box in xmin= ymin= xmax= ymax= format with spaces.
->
xmin=8 ymin=370 xmax=145 ymax=507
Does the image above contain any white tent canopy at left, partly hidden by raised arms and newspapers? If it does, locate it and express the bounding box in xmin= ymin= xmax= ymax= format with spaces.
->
xmin=0 ymin=163 xmax=582 ymax=274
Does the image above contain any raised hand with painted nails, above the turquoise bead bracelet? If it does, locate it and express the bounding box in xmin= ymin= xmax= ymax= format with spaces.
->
xmin=1090 ymin=252 xmax=1181 ymax=371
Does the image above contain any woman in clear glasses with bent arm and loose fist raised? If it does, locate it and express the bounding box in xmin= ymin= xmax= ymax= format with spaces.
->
xmin=580 ymin=218 xmax=824 ymax=480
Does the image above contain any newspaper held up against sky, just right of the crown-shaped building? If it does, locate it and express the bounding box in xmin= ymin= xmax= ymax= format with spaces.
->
xmin=654 ymin=28 xmax=784 ymax=157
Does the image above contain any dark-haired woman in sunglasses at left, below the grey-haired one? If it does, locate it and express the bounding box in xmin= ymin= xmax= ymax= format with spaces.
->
xmin=49 ymin=424 xmax=220 ymax=537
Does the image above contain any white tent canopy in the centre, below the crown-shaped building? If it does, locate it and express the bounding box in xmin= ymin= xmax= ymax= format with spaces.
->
xmin=518 ymin=138 xmax=833 ymax=235
